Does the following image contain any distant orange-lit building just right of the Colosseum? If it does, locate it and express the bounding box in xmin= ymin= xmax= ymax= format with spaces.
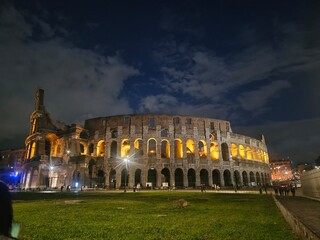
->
xmin=270 ymin=158 xmax=293 ymax=181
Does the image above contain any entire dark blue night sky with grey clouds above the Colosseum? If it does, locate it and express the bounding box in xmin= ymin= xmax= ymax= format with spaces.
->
xmin=0 ymin=0 xmax=320 ymax=163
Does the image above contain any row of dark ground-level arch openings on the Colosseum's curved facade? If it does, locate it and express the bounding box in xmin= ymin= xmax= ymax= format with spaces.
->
xmin=85 ymin=168 xmax=270 ymax=188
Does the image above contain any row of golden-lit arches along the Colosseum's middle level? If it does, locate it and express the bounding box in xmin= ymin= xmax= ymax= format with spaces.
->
xmin=87 ymin=138 xmax=269 ymax=162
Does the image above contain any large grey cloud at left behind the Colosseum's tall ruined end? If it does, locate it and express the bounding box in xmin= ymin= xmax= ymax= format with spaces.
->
xmin=0 ymin=6 xmax=139 ymax=146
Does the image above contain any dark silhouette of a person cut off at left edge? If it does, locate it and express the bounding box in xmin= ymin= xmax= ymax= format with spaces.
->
xmin=0 ymin=181 xmax=13 ymax=239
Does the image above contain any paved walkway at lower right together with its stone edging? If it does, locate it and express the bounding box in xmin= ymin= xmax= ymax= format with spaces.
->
xmin=275 ymin=196 xmax=320 ymax=239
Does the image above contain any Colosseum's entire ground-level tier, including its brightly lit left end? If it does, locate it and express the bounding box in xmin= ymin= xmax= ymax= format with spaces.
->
xmin=21 ymin=165 xmax=270 ymax=189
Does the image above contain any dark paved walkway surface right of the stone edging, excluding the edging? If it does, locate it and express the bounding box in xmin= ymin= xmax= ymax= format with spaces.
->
xmin=277 ymin=196 xmax=320 ymax=239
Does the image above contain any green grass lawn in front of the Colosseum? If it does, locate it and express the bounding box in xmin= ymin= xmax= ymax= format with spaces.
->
xmin=13 ymin=191 xmax=297 ymax=240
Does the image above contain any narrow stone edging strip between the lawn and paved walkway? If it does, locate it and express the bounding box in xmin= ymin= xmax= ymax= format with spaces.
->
xmin=273 ymin=196 xmax=320 ymax=240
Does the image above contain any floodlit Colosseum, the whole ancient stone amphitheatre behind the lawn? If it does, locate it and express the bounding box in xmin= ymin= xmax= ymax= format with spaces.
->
xmin=21 ymin=89 xmax=270 ymax=189
